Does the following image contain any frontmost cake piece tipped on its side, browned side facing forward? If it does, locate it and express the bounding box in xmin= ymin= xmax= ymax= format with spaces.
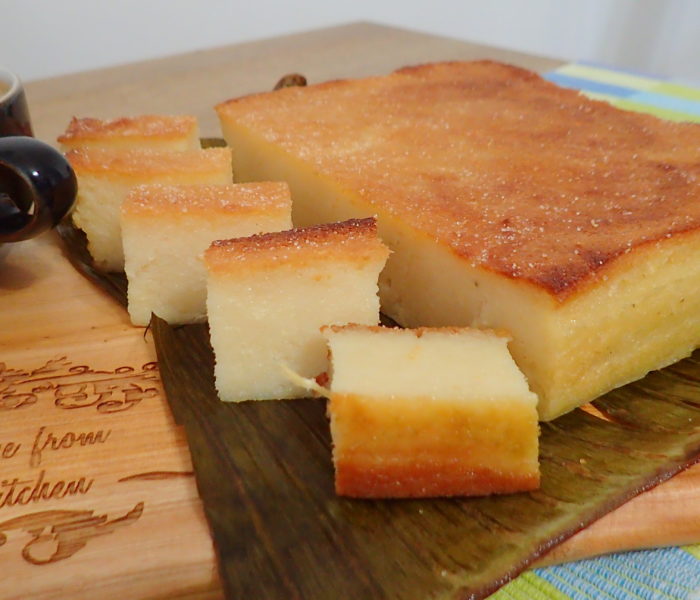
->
xmin=322 ymin=325 xmax=540 ymax=498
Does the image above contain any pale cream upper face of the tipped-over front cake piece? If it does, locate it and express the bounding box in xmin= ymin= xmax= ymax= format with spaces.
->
xmin=323 ymin=327 xmax=536 ymax=398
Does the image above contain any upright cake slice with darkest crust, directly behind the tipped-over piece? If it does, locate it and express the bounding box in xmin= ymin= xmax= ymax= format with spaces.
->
xmin=205 ymin=218 xmax=389 ymax=401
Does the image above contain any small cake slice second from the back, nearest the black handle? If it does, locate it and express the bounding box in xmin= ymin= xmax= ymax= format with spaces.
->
xmin=66 ymin=148 xmax=233 ymax=271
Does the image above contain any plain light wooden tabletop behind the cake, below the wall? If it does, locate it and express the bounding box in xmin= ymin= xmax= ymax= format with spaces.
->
xmin=26 ymin=23 xmax=561 ymax=141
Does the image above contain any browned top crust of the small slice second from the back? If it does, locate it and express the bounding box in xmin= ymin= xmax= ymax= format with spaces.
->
xmin=66 ymin=148 xmax=231 ymax=179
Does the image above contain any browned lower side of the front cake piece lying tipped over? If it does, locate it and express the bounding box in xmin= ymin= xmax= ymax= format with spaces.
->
xmin=328 ymin=393 xmax=540 ymax=498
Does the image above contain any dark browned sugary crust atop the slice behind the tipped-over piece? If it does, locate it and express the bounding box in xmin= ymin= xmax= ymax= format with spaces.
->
xmin=204 ymin=217 xmax=389 ymax=273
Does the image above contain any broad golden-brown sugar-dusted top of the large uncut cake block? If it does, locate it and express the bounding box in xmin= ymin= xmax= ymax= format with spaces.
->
xmin=217 ymin=61 xmax=700 ymax=301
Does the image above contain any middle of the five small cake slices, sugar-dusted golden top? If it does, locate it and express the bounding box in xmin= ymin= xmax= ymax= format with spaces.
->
xmin=121 ymin=182 xmax=292 ymax=325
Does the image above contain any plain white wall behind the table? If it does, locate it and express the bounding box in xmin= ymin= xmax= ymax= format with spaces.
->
xmin=0 ymin=0 xmax=700 ymax=84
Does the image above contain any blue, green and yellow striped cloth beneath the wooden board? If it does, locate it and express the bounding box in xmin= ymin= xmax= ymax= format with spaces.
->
xmin=489 ymin=63 xmax=700 ymax=600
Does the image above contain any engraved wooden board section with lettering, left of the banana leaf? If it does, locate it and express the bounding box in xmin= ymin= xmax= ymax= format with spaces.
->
xmin=0 ymin=234 xmax=220 ymax=599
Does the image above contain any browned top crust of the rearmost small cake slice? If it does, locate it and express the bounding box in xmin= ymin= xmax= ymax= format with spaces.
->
xmin=58 ymin=115 xmax=198 ymax=146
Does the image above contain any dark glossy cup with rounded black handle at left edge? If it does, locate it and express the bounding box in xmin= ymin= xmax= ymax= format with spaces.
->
xmin=0 ymin=68 xmax=77 ymax=243
